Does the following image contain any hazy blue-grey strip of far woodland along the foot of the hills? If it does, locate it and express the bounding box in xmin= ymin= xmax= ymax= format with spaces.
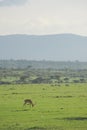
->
xmin=0 ymin=60 xmax=87 ymax=70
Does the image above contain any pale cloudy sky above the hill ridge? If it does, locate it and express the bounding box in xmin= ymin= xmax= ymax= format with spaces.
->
xmin=0 ymin=0 xmax=87 ymax=36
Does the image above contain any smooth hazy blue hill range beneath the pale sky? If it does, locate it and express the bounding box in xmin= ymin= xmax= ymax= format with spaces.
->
xmin=0 ymin=34 xmax=87 ymax=61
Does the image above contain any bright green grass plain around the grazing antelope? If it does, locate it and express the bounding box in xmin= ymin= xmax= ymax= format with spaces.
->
xmin=0 ymin=83 xmax=87 ymax=130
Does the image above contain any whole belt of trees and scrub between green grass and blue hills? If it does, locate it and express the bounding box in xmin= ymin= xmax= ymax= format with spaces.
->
xmin=0 ymin=60 xmax=87 ymax=85
